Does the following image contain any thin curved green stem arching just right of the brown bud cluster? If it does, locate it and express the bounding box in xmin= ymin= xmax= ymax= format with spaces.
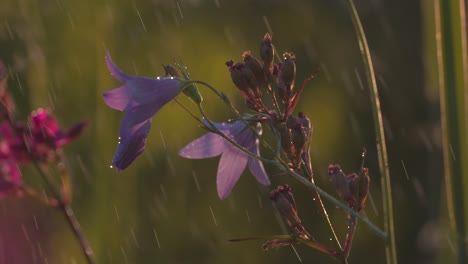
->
xmin=348 ymin=0 xmax=398 ymax=263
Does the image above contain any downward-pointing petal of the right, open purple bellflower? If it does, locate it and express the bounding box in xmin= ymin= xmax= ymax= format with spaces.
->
xmin=216 ymin=147 xmax=248 ymax=200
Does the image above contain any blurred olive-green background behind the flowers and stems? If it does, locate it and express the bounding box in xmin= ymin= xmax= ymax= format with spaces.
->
xmin=0 ymin=0 xmax=450 ymax=264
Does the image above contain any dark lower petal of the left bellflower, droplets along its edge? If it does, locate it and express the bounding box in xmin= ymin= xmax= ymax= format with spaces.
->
xmin=112 ymin=112 xmax=151 ymax=172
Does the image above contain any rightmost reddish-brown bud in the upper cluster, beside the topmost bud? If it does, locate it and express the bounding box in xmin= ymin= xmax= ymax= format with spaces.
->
xmin=276 ymin=52 xmax=296 ymax=103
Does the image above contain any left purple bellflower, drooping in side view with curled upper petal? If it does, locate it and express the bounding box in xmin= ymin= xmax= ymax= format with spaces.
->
xmin=103 ymin=53 xmax=186 ymax=172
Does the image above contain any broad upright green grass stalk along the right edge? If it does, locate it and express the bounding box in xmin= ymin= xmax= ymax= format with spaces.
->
xmin=433 ymin=0 xmax=468 ymax=264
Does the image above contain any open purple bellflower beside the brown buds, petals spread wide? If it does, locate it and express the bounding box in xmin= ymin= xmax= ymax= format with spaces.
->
xmin=179 ymin=120 xmax=270 ymax=199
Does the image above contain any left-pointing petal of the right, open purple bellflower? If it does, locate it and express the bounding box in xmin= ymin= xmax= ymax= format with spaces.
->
xmin=179 ymin=133 xmax=226 ymax=159
